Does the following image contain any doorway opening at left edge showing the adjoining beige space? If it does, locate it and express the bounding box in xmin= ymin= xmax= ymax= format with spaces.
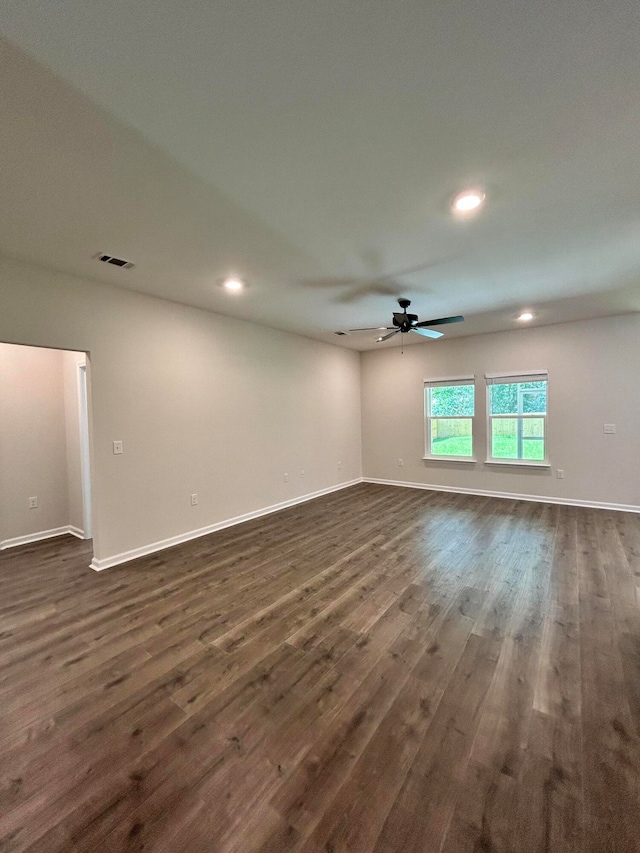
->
xmin=0 ymin=343 xmax=93 ymax=549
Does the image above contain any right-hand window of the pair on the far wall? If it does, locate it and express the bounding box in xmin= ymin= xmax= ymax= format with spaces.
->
xmin=487 ymin=371 xmax=548 ymax=465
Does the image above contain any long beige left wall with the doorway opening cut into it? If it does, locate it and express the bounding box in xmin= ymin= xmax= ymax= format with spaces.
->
xmin=0 ymin=259 xmax=361 ymax=561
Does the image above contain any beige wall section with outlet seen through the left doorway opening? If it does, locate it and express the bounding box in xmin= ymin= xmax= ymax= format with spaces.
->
xmin=0 ymin=344 xmax=69 ymax=541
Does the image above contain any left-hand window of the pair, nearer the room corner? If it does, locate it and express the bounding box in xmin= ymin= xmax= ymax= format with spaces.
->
xmin=424 ymin=376 xmax=475 ymax=461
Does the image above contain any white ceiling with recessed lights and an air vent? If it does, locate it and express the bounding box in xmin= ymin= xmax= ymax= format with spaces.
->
xmin=0 ymin=0 xmax=640 ymax=349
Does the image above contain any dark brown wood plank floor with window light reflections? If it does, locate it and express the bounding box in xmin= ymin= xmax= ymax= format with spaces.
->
xmin=0 ymin=485 xmax=640 ymax=853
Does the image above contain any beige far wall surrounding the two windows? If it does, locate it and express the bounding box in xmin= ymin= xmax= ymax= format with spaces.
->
xmin=362 ymin=314 xmax=640 ymax=507
